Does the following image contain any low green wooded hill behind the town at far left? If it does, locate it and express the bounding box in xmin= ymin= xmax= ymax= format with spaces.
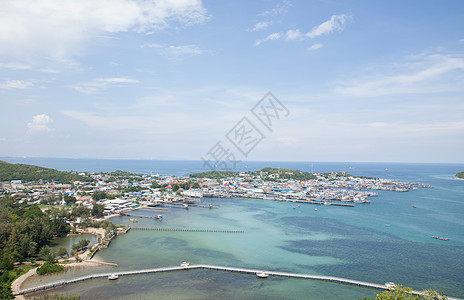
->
xmin=0 ymin=160 xmax=89 ymax=183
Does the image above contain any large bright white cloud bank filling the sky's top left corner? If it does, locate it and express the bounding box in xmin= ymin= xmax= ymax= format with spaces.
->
xmin=0 ymin=0 xmax=207 ymax=60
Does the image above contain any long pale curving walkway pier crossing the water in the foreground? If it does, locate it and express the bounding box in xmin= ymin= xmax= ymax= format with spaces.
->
xmin=13 ymin=264 xmax=456 ymax=299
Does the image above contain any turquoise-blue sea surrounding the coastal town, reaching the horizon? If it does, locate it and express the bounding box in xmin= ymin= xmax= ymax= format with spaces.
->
xmin=0 ymin=158 xmax=464 ymax=299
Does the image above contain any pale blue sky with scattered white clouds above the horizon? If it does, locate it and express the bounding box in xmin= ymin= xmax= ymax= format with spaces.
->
xmin=0 ymin=0 xmax=464 ymax=163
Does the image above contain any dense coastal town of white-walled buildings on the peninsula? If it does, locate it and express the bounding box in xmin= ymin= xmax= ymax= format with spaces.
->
xmin=0 ymin=168 xmax=430 ymax=214
